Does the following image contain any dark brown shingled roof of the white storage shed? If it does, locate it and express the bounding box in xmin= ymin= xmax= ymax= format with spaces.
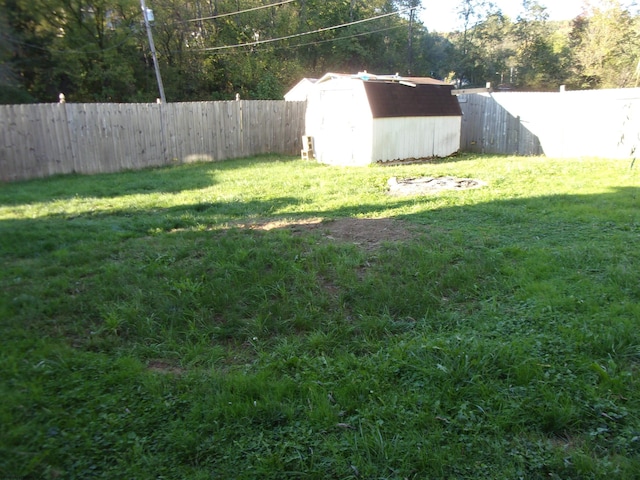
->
xmin=364 ymin=77 xmax=462 ymax=118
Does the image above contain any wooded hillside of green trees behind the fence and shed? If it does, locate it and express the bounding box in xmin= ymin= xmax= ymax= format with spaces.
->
xmin=0 ymin=0 xmax=640 ymax=103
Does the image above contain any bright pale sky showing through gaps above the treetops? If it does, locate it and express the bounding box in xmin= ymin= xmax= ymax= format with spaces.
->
xmin=420 ymin=0 xmax=584 ymax=32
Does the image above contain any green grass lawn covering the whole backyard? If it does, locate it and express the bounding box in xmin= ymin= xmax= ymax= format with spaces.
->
xmin=0 ymin=155 xmax=640 ymax=479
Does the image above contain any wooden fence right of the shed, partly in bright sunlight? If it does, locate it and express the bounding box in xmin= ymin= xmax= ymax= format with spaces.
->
xmin=458 ymin=88 xmax=640 ymax=158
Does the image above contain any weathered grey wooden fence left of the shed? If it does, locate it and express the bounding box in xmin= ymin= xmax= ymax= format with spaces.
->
xmin=0 ymin=100 xmax=306 ymax=181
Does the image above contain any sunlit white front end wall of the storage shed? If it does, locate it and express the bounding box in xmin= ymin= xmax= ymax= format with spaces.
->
xmin=306 ymin=79 xmax=373 ymax=165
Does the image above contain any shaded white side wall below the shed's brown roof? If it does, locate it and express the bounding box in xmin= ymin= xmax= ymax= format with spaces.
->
xmin=371 ymin=117 xmax=462 ymax=162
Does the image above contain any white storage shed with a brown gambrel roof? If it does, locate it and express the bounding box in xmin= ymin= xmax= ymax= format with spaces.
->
xmin=306 ymin=72 xmax=462 ymax=165
